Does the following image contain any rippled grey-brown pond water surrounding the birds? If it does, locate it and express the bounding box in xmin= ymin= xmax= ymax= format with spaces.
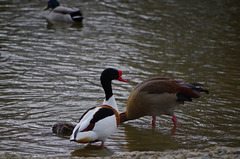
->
xmin=0 ymin=0 xmax=240 ymax=157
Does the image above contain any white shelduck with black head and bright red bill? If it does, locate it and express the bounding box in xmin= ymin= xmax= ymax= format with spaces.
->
xmin=70 ymin=68 xmax=126 ymax=147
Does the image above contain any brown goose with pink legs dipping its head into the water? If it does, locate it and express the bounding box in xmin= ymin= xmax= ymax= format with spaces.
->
xmin=120 ymin=77 xmax=209 ymax=128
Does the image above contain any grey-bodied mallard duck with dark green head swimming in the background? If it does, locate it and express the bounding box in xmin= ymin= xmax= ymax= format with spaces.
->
xmin=44 ymin=0 xmax=83 ymax=23
